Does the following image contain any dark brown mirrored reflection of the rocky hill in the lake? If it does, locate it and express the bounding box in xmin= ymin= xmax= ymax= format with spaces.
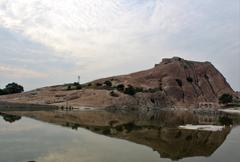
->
xmin=2 ymin=111 xmax=235 ymax=160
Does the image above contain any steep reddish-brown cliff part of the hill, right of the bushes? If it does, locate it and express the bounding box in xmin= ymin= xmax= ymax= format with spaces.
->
xmin=95 ymin=57 xmax=234 ymax=107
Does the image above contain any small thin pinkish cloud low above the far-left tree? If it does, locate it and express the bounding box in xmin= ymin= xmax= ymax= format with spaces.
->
xmin=0 ymin=65 xmax=48 ymax=78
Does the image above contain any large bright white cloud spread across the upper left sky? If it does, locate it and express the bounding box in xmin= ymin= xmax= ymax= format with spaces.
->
xmin=0 ymin=0 xmax=182 ymax=59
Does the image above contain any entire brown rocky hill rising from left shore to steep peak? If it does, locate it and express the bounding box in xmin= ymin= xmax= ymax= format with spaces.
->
xmin=0 ymin=57 xmax=235 ymax=108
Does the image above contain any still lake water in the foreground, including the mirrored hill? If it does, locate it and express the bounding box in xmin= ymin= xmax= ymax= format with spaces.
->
xmin=0 ymin=112 xmax=240 ymax=162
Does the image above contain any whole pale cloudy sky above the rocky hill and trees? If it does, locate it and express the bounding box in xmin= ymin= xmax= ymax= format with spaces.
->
xmin=0 ymin=0 xmax=240 ymax=90
